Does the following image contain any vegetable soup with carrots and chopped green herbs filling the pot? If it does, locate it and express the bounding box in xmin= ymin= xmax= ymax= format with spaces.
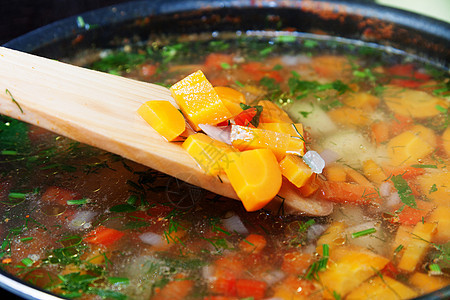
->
xmin=0 ymin=35 xmax=450 ymax=300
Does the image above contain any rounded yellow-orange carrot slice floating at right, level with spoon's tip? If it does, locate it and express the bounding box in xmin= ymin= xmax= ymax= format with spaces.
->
xmin=387 ymin=131 xmax=434 ymax=166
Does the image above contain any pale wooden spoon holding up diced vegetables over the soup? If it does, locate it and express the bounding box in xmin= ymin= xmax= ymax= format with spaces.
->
xmin=0 ymin=47 xmax=333 ymax=216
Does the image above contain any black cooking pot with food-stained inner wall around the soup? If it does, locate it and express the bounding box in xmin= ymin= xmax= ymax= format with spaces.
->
xmin=0 ymin=0 xmax=450 ymax=299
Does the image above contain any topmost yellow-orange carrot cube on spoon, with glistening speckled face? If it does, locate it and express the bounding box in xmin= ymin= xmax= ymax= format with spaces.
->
xmin=170 ymin=71 xmax=232 ymax=131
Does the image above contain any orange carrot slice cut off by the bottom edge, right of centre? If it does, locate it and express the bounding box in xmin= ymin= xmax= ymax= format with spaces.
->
xmin=345 ymin=276 xmax=418 ymax=300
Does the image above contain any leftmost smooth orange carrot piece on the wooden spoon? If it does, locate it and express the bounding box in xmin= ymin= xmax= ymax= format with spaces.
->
xmin=138 ymin=101 xmax=186 ymax=141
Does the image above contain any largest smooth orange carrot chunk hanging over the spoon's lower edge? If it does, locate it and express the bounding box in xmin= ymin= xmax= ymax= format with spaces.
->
xmin=225 ymin=149 xmax=281 ymax=211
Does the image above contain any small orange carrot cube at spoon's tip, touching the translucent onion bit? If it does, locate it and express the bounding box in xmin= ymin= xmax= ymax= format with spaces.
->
xmin=280 ymin=154 xmax=313 ymax=187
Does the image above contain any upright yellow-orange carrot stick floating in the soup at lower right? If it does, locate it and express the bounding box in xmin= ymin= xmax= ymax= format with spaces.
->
xmin=398 ymin=222 xmax=437 ymax=272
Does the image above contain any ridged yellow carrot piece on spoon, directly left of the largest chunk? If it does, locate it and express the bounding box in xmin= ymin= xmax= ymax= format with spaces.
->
xmin=181 ymin=133 xmax=234 ymax=175
